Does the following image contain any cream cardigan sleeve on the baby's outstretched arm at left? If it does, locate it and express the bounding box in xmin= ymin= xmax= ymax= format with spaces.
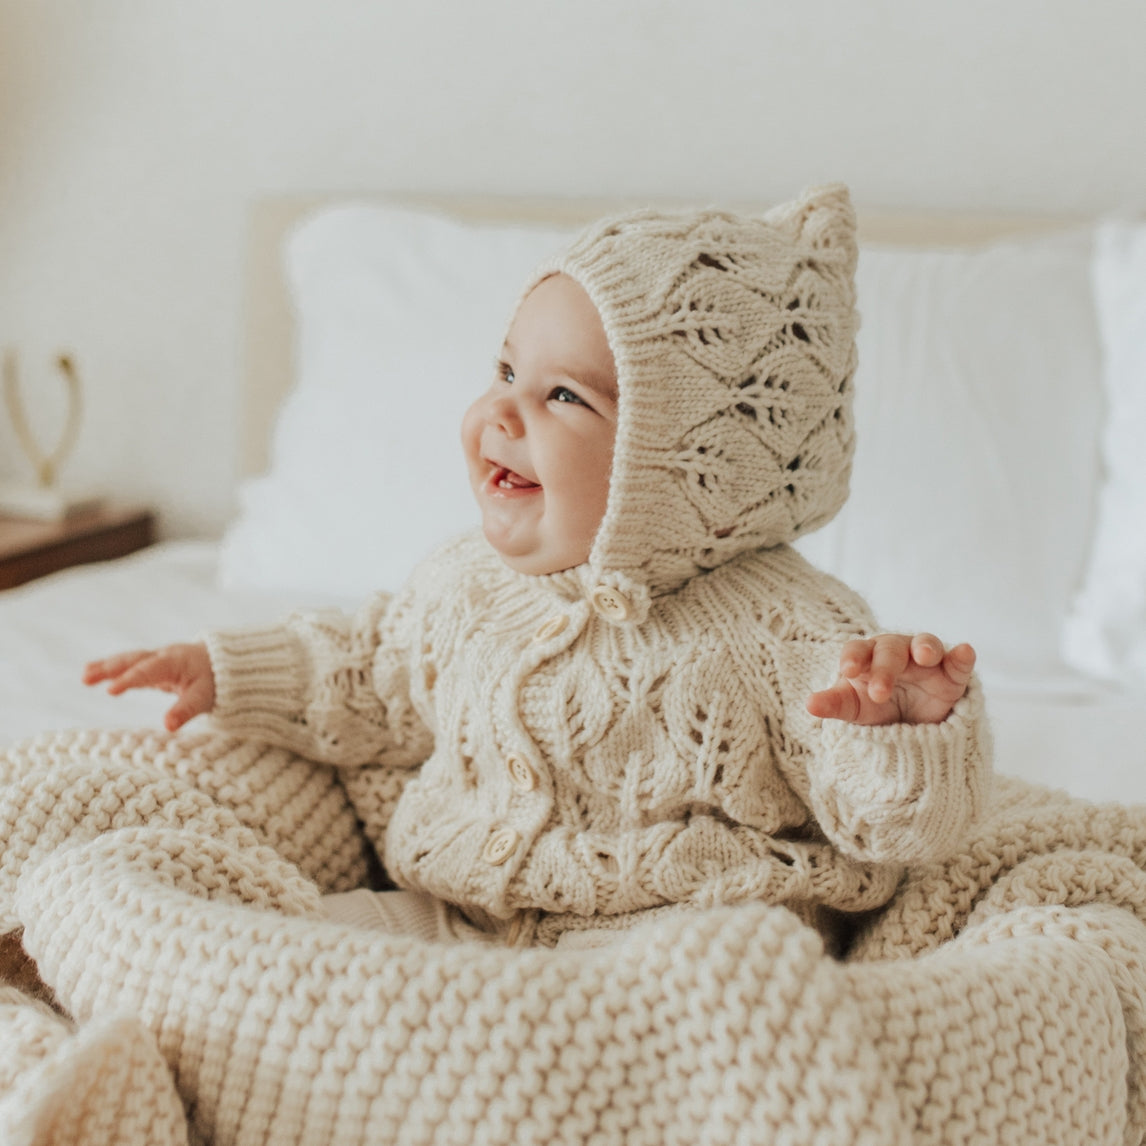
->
xmin=206 ymin=594 xmax=433 ymax=767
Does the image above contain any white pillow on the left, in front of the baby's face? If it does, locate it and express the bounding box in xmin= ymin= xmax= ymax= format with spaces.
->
xmin=220 ymin=204 xmax=568 ymax=603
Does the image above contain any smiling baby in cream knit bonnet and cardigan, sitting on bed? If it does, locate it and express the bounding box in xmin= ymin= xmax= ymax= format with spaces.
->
xmin=85 ymin=186 xmax=990 ymax=945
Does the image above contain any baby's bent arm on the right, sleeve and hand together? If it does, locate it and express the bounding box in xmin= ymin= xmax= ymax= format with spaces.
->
xmin=755 ymin=548 xmax=991 ymax=864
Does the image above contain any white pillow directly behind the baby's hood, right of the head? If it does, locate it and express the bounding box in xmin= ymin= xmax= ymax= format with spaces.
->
xmin=800 ymin=231 xmax=1102 ymax=688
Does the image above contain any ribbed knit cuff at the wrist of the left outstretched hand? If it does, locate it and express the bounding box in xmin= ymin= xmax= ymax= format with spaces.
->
xmin=205 ymin=626 xmax=307 ymax=739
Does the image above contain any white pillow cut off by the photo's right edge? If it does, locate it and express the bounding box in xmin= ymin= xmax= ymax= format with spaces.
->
xmin=1063 ymin=221 xmax=1146 ymax=686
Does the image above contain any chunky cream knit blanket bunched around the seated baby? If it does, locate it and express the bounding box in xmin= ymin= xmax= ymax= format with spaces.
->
xmin=0 ymin=733 xmax=1146 ymax=1146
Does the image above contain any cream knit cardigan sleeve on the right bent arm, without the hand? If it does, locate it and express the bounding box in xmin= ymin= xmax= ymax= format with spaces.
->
xmin=771 ymin=554 xmax=991 ymax=864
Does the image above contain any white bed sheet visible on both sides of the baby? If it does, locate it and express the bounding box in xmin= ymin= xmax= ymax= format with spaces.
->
xmin=0 ymin=542 xmax=1146 ymax=803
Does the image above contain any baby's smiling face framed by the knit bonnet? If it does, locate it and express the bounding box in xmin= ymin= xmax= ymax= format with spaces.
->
xmin=462 ymin=275 xmax=617 ymax=575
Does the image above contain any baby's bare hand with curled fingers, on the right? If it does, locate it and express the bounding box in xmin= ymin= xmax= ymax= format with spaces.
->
xmin=808 ymin=633 xmax=975 ymax=724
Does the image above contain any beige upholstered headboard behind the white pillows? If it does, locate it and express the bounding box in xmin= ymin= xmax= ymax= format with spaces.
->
xmin=241 ymin=194 xmax=1080 ymax=474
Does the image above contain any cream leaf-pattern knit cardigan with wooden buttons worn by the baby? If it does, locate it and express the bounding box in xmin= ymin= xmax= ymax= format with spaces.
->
xmin=209 ymin=535 xmax=989 ymax=943
